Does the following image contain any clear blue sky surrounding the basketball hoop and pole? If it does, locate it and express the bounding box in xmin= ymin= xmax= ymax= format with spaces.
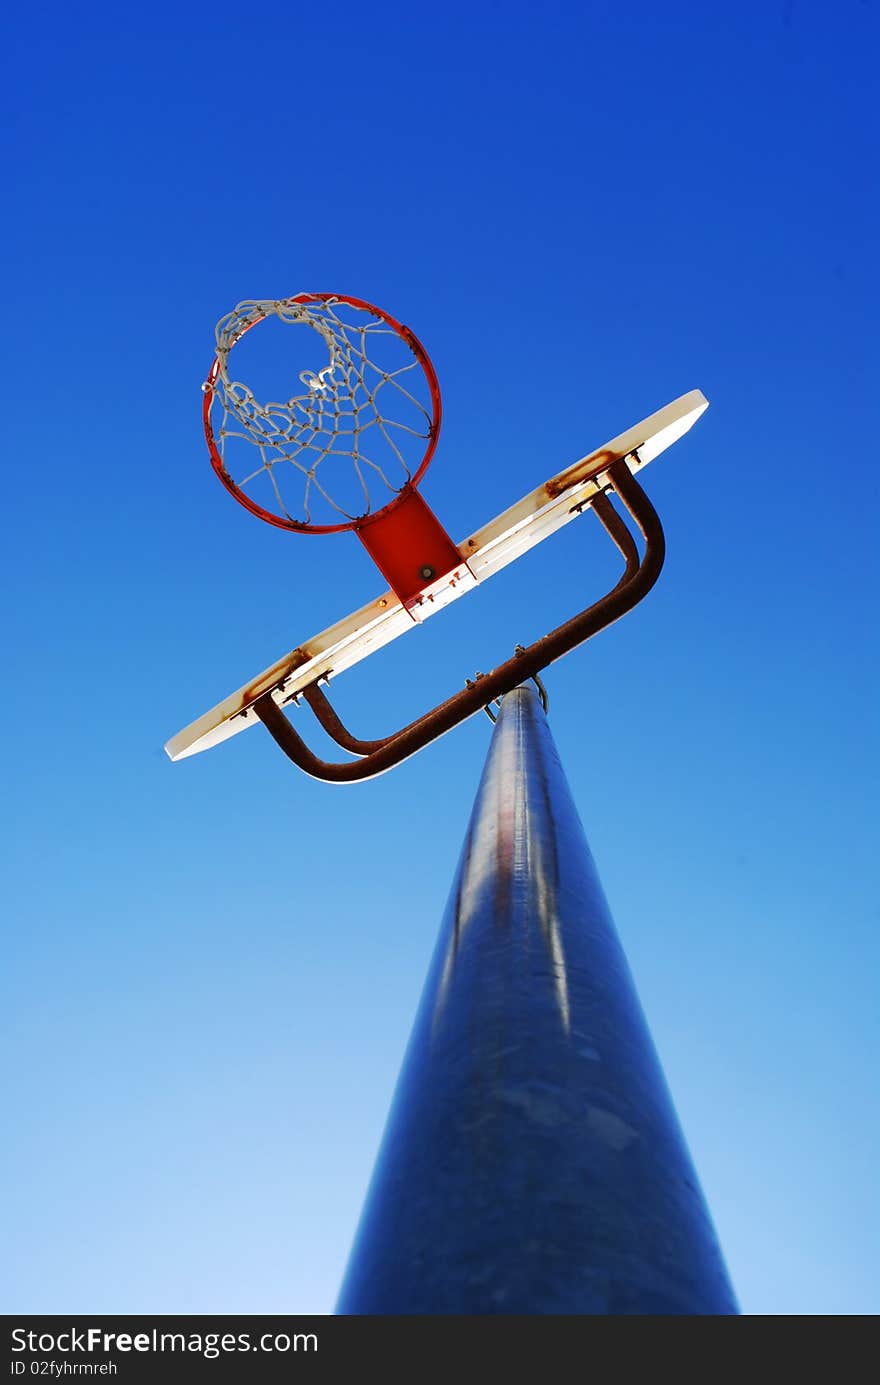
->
xmin=0 ymin=0 xmax=880 ymax=1313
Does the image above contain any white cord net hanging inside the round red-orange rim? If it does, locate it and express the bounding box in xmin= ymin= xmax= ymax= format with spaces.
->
xmin=206 ymin=295 xmax=435 ymax=528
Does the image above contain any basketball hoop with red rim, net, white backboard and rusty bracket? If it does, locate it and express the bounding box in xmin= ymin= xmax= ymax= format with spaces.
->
xmin=166 ymin=283 xmax=708 ymax=783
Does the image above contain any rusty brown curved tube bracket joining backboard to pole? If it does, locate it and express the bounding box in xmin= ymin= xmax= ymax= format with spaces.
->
xmin=254 ymin=461 xmax=665 ymax=784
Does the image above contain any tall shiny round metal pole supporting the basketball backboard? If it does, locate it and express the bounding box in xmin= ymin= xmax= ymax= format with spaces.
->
xmin=337 ymin=687 xmax=737 ymax=1314
